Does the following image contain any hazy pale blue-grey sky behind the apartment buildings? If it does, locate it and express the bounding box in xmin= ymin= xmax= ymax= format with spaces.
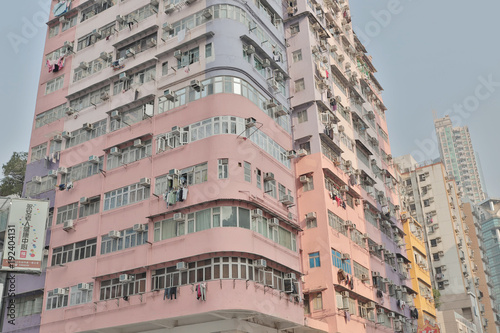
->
xmin=0 ymin=0 xmax=500 ymax=196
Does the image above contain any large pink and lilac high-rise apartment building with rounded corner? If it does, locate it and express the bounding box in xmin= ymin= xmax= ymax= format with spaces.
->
xmin=21 ymin=0 xmax=416 ymax=333
